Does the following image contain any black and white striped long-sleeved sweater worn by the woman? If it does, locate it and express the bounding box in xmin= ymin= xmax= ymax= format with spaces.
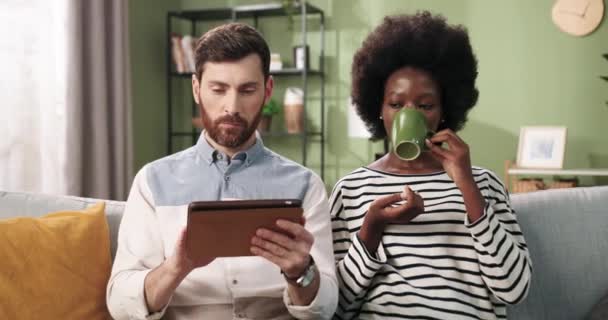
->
xmin=330 ymin=167 xmax=532 ymax=319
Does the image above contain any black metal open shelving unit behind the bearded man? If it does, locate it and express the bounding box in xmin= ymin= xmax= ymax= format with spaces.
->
xmin=166 ymin=0 xmax=326 ymax=178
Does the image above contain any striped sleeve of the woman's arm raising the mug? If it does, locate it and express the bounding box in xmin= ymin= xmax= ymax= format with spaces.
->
xmin=465 ymin=171 xmax=532 ymax=304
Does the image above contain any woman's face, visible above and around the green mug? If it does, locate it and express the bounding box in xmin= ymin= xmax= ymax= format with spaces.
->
xmin=381 ymin=67 xmax=443 ymax=136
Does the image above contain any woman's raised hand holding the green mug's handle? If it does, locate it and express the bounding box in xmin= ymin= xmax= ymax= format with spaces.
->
xmin=426 ymin=129 xmax=474 ymax=187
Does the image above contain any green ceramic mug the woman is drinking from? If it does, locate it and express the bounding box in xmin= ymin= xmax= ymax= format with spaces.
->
xmin=391 ymin=108 xmax=435 ymax=161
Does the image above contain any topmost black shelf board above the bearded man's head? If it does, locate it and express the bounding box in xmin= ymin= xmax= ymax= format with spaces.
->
xmin=169 ymin=3 xmax=323 ymax=21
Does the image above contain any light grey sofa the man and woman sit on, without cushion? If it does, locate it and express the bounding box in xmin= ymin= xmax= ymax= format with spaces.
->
xmin=0 ymin=186 xmax=608 ymax=320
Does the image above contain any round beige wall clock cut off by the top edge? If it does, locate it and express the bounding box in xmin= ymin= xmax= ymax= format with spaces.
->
xmin=551 ymin=0 xmax=604 ymax=36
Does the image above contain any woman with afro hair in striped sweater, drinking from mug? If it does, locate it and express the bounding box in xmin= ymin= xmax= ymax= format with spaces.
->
xmin=330 ymin=12 xmax=532 ymax=319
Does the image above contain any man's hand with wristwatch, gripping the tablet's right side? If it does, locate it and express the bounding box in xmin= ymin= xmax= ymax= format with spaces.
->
xmin=251 ymin=220 xmax=314 ymax=278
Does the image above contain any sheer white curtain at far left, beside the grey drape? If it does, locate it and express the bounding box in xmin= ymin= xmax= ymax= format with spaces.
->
xmin=0 ymin=0 xmax=67 ymax=194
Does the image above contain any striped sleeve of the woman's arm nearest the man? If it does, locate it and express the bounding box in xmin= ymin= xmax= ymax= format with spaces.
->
xmin=330 ymin=183 xmax=386 ymax=319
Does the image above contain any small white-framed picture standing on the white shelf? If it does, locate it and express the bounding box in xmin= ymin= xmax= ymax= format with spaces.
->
xmin=517 ymin=126 xmax=567 ymax=169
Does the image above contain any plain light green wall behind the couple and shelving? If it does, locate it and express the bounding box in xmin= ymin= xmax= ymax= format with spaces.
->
xmin=129 ymin=0 xmax=608 ymax=188
